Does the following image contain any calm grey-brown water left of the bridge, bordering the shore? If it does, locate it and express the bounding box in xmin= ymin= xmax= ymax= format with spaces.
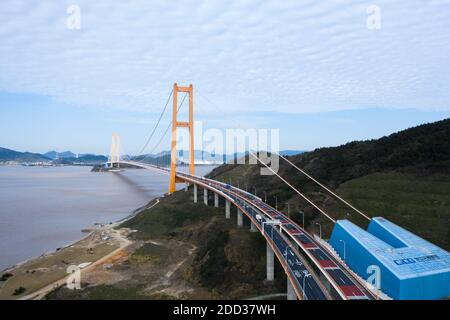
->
xmin=0 ymin=165 xmax=162 ymax=276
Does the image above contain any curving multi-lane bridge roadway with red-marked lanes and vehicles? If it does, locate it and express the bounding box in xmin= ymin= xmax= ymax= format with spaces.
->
xmin=117 ymin=161 xmax=376 ymax=300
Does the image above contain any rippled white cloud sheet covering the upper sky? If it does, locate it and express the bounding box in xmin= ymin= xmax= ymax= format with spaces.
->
xmin=0 ymin=0 xmax=450 ymax=113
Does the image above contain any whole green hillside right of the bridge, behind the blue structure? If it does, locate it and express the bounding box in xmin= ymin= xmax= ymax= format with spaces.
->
xmin=210 ymin=119 xmax=450 ymax=250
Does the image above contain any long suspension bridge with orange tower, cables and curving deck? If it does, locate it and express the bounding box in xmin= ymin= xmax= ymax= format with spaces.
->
xmin=105 ymin=83 xmax=379 ymax=300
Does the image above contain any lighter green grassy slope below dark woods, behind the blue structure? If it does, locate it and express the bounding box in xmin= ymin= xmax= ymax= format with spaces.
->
xmin=330 ymin=172 xmax=450 ymax=250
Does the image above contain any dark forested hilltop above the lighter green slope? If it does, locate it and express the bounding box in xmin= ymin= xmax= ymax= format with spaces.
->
xmin=290 ymin=119 xmax=450 ymax=186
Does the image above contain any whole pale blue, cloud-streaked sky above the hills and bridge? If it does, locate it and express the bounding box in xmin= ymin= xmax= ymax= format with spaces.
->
xmin=0 ymin=0 xmax=450 ymax=154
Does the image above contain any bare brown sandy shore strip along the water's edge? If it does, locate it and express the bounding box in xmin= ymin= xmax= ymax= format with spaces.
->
xmin=0 ymin=166 xmax=214 ymax=300
